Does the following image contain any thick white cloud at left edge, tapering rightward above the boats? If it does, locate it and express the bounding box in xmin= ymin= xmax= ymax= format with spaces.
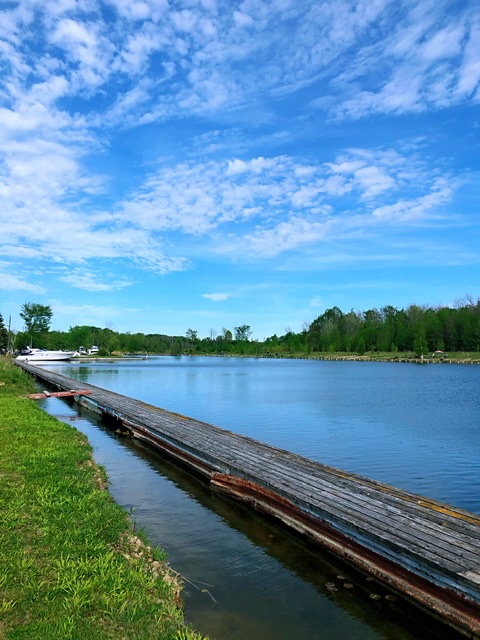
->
xmin=0 ymin=141 xmax=188 ymax=276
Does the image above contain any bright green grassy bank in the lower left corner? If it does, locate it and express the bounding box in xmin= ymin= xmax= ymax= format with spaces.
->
xmin=0 ymin=358 xmax=206 ymax=640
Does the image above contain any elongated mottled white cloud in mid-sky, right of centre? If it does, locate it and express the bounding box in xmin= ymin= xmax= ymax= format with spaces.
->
xmin=112 ymin=149 xmax=462 ymax=264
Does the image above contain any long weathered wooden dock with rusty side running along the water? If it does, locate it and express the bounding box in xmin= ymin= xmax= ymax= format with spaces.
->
xmin=19 ymin=363 xmax=480 ymax=637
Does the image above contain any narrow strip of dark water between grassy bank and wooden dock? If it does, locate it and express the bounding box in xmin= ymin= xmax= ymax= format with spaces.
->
xmin=50 ymin=399 xmax=466 ymax=640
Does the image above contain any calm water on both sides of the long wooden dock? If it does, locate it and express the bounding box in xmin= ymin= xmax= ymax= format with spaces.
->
xmin=39 ymin=357 xmax=480 ymax=640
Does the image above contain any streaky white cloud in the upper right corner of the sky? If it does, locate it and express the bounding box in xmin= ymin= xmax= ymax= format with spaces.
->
xmin=328 ymin=2 xmax=480 ymax=119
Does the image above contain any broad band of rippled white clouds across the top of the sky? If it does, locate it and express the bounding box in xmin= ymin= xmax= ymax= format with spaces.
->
xmin=0 ymin=0 xmax=480 ymax=144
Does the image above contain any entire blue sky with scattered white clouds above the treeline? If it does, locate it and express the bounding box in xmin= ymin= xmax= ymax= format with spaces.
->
xmin=0 ymin=0 xmax=480 ymax=339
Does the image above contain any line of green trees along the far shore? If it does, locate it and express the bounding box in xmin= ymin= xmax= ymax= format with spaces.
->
xmin=0 ymin=298 xmax=480 ymax=356
